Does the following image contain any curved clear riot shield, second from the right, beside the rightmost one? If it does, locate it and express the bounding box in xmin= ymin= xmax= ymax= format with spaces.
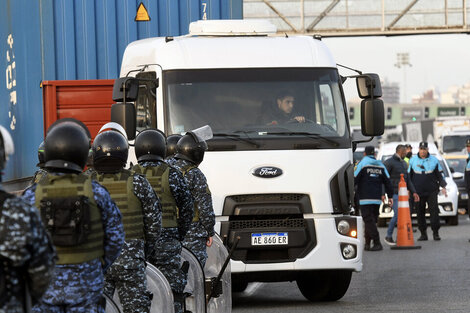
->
xmin=181 ymin=247 xmax=206 ymax=313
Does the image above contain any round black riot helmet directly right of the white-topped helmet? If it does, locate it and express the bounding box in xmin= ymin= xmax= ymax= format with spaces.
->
xmin=134 ymin=129 xmax=166 ymax=162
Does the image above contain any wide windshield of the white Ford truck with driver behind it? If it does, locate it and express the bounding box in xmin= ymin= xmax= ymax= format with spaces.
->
xmin=163 ymin=68 xmax=350 ymax=150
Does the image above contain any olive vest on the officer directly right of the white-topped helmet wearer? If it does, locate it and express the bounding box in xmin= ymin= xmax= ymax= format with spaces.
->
xmin=132 ymin=163 xmax=178 ymax=228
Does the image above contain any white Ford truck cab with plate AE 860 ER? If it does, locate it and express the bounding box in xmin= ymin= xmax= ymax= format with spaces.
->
xmin=112 ymin=20 xmax=384 ymax=301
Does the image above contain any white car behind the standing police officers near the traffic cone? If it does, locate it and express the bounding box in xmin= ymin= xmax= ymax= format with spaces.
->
xmin=377 ymin=142 xmax=459 ymax=226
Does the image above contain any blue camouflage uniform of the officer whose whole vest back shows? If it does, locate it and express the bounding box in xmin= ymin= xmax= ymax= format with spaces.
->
xmin=23 ymin=177 xmax=124 ymax=313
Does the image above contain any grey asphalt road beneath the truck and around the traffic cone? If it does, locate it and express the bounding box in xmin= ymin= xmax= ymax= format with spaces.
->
xmin=233 ymin=215 xmax=470 ymax=313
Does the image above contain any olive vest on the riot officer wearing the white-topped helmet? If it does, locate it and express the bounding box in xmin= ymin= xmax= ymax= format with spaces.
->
xmin=96 ymin=169 xmax=144 ymax=241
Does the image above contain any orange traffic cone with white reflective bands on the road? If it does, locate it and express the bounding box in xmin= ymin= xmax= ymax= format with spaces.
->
xmin=391 ymin=174 xmax=421 ymax=249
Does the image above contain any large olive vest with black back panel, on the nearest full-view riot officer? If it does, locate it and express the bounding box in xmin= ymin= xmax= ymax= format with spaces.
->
xmin=35 ymin=174 xmax=104 ymax=264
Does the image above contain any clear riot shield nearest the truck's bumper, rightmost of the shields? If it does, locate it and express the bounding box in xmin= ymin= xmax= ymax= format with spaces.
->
xmin=204 ymin=235 xmax=232 ymax=313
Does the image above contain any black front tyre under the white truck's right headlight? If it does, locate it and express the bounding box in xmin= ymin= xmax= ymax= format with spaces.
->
xmin=297 ymin=270 xmax=352 ymax=302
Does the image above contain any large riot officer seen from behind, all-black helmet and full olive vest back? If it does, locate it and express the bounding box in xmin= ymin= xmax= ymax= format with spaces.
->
xmin=24 ymin=119 xmax=124 ymax=312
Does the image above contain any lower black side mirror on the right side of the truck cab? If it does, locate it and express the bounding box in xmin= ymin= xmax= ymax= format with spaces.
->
xmin=361 ymin=99 xmax=385 ymax=136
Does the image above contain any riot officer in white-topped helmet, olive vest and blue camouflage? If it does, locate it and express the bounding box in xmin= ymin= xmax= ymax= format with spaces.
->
xmin=92 ymin=125 xmax=162 ymax=312
